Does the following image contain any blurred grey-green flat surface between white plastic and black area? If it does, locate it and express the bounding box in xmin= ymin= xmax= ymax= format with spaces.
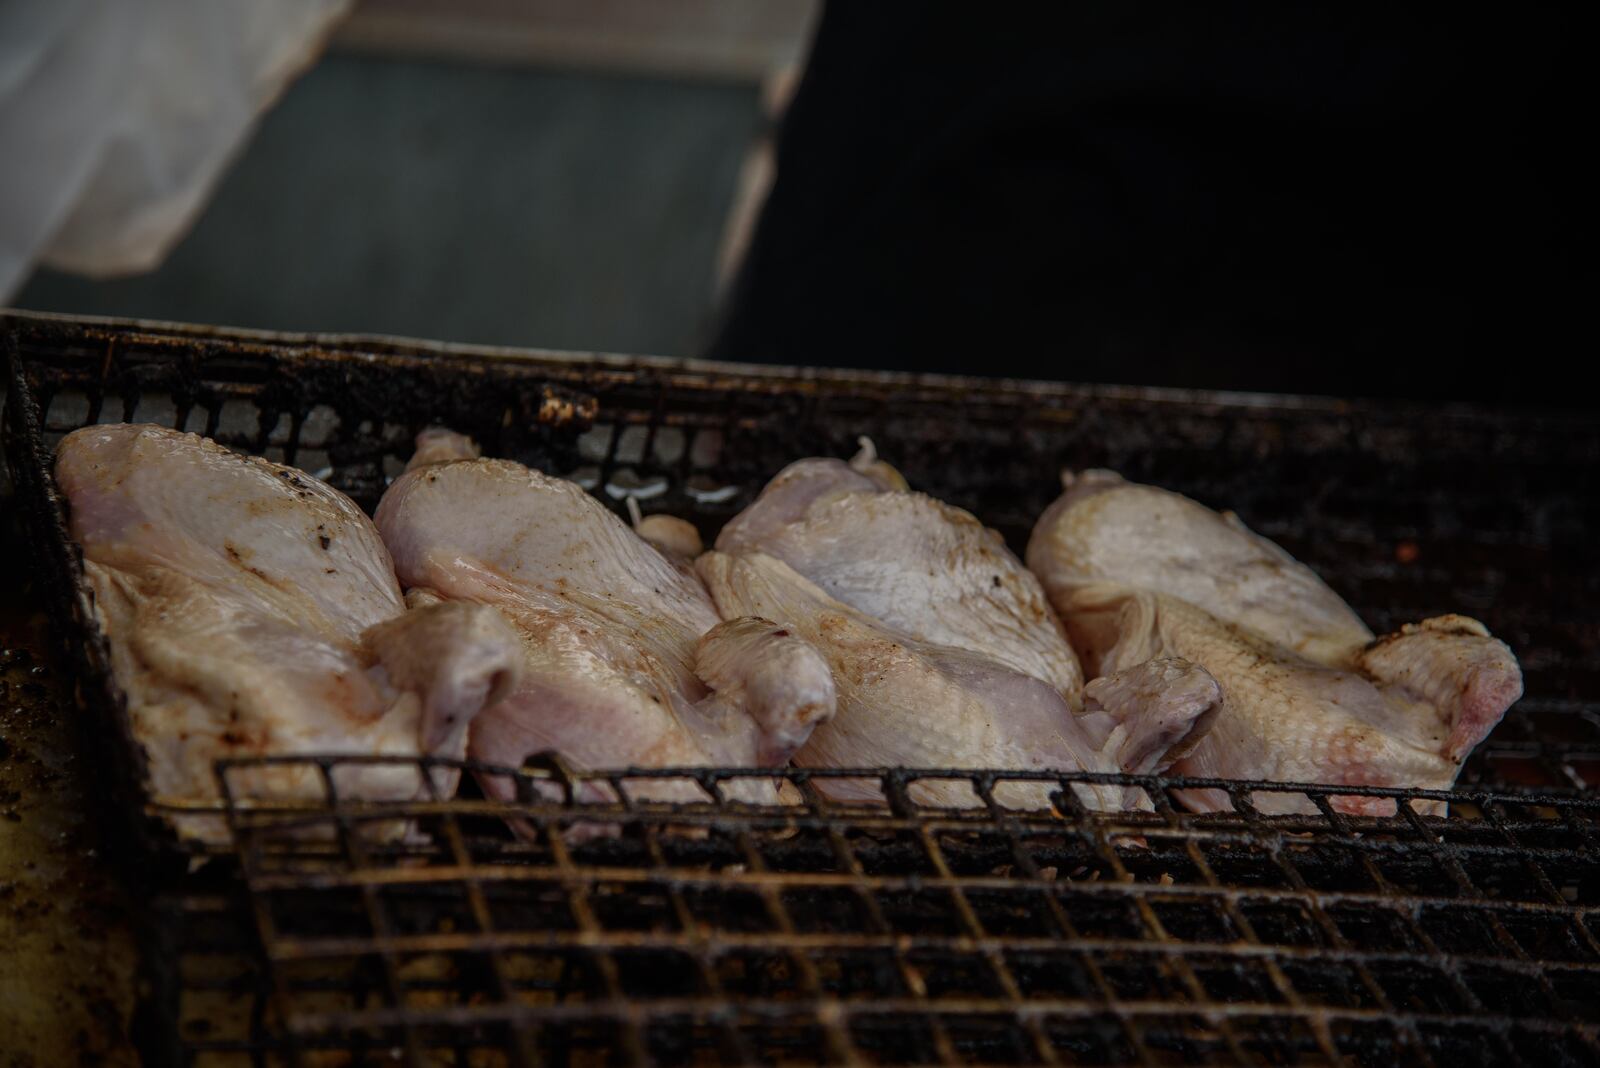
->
xmin=14 ymin=54 xmax=762 ymax=355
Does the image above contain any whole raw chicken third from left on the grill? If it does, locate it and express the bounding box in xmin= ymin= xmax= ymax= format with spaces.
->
xmin=701 ymin=440 xmax=1218 ymax=809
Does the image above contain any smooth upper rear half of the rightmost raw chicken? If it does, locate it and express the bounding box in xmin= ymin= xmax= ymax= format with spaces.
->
xmin=1027 ymin=470 xmax=1373 ymax=664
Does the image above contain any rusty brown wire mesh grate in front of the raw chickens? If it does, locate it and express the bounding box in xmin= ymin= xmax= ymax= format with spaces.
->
xmin=209 ymin=759 xmax=1600 ymax=1065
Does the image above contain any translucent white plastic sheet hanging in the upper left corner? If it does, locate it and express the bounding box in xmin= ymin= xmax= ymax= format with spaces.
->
xmin=0 ymin=0 xmax=350 ymax=304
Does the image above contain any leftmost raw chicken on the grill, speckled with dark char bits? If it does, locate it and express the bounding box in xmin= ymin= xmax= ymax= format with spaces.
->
xmin=56 ymin=425 xmax=520 ymax=839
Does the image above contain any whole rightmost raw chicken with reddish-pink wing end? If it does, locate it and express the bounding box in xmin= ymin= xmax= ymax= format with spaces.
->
xmin=1027 ymin=472 xmax=1522 ymax=815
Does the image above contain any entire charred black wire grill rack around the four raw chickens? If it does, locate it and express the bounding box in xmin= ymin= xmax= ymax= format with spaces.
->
xmin=0 ymin=317 xmax=1600 ymax=1066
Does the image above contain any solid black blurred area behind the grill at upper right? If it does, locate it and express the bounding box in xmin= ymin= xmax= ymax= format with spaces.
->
xmin=715 ymin=3 xmax=1597 ymax=404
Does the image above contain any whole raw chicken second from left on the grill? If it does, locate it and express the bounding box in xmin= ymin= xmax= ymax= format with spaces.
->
xmin=368 ymin=435 xmax=834 ymax=803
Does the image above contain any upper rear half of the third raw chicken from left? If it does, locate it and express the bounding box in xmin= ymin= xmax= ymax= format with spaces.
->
xmin=717 ymin=438 xmax=1083 ymax=705
